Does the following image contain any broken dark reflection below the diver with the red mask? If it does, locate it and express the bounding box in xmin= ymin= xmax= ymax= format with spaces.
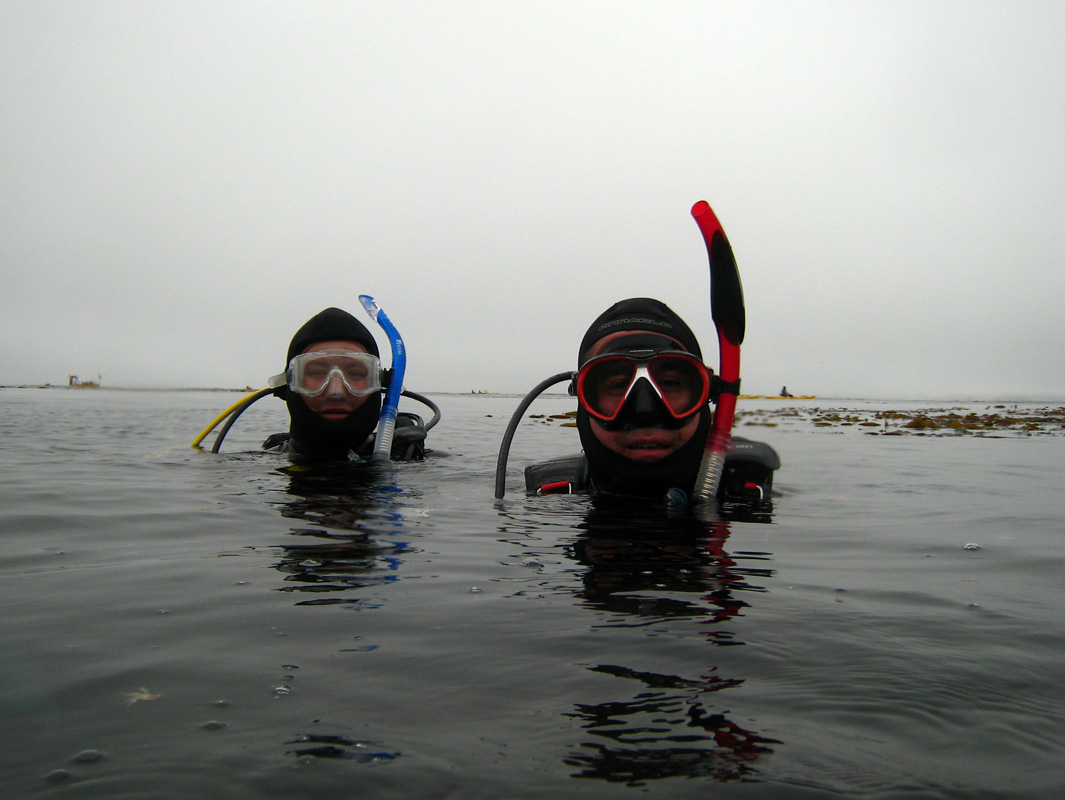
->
xmin=564 ymin=502 xmax=781 ymax=784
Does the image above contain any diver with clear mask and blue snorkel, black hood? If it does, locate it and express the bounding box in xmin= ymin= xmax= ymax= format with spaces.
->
xmin=193 ymin=295 xmax=440 ymax=463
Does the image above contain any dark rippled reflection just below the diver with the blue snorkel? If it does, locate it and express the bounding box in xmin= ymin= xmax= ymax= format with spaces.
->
xmin=275 ymin=464 xmax=416 ymax=607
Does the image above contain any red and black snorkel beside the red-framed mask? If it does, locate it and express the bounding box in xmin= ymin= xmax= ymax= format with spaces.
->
xmin=691 ymin=200 xmax=747 ymax=501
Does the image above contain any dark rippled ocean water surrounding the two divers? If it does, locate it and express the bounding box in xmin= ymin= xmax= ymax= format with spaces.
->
xmin=0 ymin=389 xmax=1065 ymax=800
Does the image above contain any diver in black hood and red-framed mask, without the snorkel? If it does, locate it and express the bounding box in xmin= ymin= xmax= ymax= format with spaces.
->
xmin=496 ymin=297 xmax=780 ymax=503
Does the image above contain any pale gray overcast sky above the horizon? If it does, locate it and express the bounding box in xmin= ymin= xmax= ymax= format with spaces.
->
xmin=0 ymin=0 xmax=1065 ymax=399
